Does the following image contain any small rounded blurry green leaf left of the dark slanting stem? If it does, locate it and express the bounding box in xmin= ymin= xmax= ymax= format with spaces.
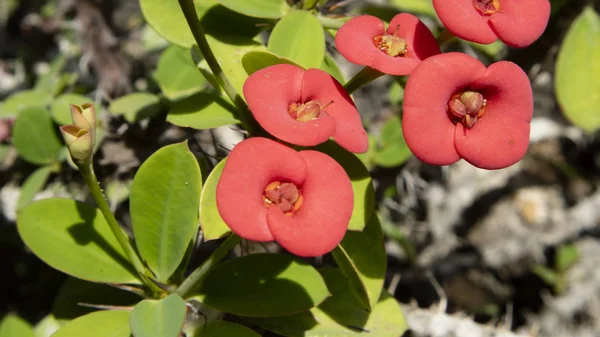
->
xmin=152 ymin=45 xmax=206 ymax=101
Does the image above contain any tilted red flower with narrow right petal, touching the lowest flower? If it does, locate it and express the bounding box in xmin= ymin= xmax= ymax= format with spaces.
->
xmin=244 ymin=64 xmax=369 ymax=153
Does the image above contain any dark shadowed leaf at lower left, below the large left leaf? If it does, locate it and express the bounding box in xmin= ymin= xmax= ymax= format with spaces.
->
xmin=52 ymin=277 xmax=140 ymax=324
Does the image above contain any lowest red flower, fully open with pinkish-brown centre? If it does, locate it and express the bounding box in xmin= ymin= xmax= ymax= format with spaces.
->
xmin=217 ymin=137 xmax=354 ymax=256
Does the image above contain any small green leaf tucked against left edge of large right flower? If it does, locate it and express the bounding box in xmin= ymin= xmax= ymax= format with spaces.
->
xmin=374 ymin=116 xmax=412 ymax=167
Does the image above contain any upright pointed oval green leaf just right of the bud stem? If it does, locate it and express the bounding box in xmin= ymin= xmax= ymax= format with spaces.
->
xmin=130 ymin=142 xmax=202 ymax=283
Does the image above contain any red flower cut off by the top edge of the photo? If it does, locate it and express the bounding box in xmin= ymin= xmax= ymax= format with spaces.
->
xmin=433 ymin=0 xmax=550 ymax=47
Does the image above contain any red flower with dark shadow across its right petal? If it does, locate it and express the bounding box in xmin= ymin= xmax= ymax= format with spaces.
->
xmin=335 ymin=13 xmax=440 ymax=75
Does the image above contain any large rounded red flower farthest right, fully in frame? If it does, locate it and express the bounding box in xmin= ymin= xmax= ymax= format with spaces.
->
xmin=402 ymin=53 xmax=533 ymax=169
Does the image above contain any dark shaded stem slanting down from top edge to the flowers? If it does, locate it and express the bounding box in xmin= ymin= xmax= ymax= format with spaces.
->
xmin=179 ymin=0 xmax=256 ymax=134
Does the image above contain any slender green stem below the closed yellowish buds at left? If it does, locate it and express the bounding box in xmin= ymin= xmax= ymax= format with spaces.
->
xmin=77 ymin=163 xmax=163 ymax=295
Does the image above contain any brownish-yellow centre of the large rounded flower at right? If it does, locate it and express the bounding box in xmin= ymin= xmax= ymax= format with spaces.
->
xmin=448 ymin=90 xmax=487 ymax=129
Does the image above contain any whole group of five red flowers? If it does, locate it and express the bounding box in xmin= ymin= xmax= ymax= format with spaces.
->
xmin=217 ymin=0 xmax=550 ymax=256
